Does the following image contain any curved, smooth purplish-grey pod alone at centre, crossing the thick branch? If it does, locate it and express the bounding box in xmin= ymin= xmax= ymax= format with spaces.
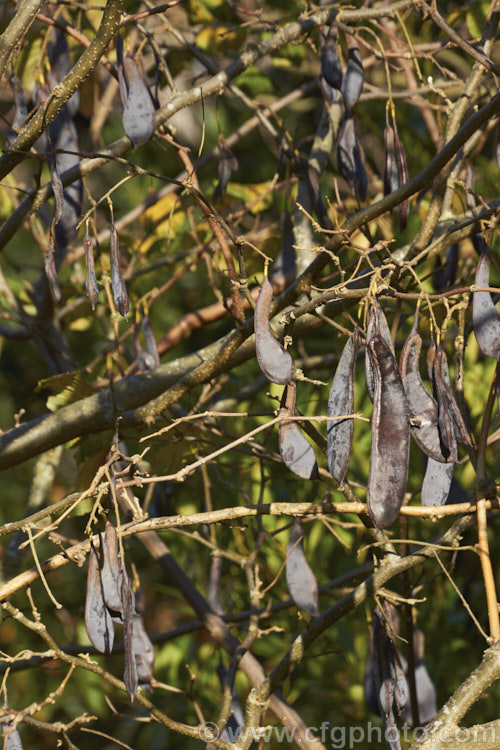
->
xmin=254 ymin=276 xmax=293 ymax=385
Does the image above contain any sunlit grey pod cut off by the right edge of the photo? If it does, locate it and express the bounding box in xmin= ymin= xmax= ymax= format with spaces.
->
xmin=472 ymin=242 xmax=500 ymax=360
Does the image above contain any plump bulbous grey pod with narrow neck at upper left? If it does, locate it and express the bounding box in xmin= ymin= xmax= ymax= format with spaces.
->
xmin=116 ymin=36 xmax=155 ymax=148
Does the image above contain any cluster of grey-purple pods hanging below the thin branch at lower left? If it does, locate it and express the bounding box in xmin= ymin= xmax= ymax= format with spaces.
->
xmin=85 ymin=522 xmax=155 ymax=700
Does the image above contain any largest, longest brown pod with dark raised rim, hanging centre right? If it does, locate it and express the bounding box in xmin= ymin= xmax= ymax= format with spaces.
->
xmin=366 ymin=334 xmax=410 ymax=529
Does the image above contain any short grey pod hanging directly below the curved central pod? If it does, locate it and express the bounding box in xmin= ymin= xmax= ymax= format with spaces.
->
xmin=279 ymin=383 xmax=319 ymax=479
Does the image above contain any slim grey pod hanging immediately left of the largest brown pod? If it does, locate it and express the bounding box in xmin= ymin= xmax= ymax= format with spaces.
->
xmin=326 ymin=325 xmax=359 ymax=485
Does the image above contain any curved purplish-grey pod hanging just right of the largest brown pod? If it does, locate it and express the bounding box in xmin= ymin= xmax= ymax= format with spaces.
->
xmin=399 ymin=311 xmax=446 ymax=462
